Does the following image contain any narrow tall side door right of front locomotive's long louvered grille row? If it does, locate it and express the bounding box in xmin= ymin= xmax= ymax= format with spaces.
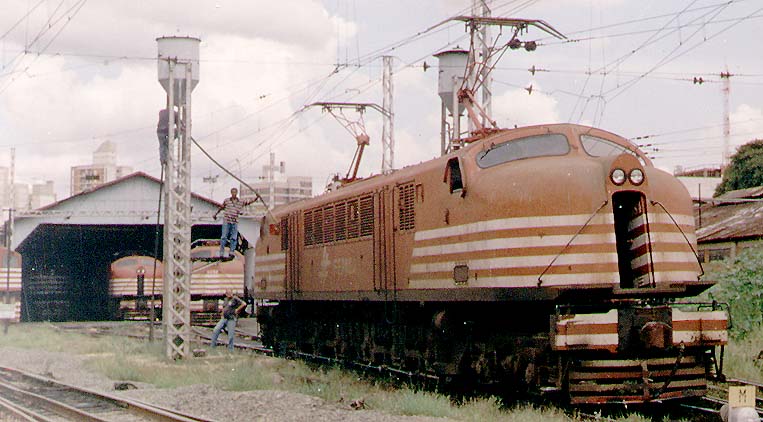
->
xmin=373 ymin=186 xmax=395 ymax=300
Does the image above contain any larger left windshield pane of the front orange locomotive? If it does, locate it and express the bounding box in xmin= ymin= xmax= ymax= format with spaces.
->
xmin=477 ymin=133 xmax=570 ymax=169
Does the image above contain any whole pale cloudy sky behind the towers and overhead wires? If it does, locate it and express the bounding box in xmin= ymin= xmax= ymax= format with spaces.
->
xmin=0 ymin=0 xmax=763 ymax=199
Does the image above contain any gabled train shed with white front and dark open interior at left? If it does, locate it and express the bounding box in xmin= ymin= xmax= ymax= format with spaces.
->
xmin=12 ymin=172 xmax=259 ymax=321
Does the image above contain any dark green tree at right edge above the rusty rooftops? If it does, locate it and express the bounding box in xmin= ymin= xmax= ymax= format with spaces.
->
xmin=715 ymin=139 xmax=763 ymax=196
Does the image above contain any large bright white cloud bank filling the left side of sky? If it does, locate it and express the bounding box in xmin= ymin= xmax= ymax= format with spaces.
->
xmin=0 ymin=0 xmax=356 ymax=196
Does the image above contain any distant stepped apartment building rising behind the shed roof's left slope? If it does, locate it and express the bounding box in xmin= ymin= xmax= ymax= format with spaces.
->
xmin=70 ymin=141 xmax=132 ymax=195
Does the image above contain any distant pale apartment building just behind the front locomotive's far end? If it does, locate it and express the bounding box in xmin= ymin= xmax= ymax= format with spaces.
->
xmin=239 ymin=153 xmax=313 ymax=215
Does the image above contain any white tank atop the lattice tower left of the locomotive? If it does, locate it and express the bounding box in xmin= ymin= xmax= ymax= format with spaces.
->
xmin=156 ymin=37 xmax=201 ymax=103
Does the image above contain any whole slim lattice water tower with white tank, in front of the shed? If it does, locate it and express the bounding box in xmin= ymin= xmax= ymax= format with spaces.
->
xmin=156 ymin=37 xmax=200 ymax=359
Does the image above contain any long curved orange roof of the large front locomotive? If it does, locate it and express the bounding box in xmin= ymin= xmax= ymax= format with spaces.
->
xmin=273 ymin=123 xmax=651 ymax=215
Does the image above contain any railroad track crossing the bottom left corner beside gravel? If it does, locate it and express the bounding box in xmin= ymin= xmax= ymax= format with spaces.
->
xmin=0 ymin=367 xmax=209 ymax=422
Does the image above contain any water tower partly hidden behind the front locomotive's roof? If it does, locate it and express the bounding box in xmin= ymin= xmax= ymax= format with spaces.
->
xmin=435 ymin=49 xmax=469 ymax=155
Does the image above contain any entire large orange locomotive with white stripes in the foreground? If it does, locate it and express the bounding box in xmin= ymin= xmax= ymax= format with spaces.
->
xmin=254 ymin=124 xmax=727 ymax=403
